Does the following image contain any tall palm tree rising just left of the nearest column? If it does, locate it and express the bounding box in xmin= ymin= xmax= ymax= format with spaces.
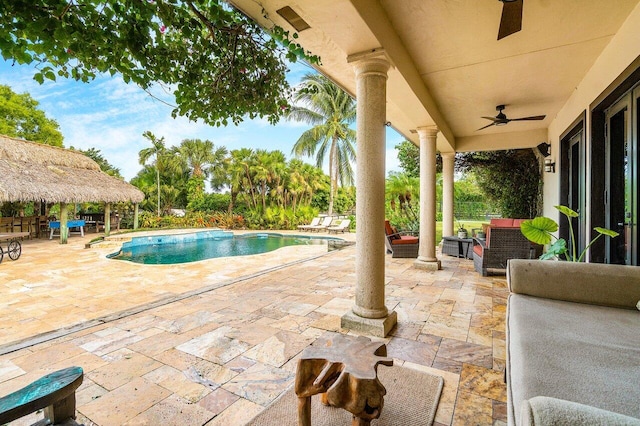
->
xmin=289 ymin=74 xmax=356 ymax=214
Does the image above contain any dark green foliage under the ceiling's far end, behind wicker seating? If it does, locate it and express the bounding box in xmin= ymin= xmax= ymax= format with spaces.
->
xmin=459 ymin=149 xmax=541 ymax=218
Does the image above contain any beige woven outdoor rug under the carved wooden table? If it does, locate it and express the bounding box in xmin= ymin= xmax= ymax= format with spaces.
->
xmin=248 ymin=366 xmax=444 ymax=426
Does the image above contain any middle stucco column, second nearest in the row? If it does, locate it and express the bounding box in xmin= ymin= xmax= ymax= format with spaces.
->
xmin=414 ymin=126 xmax=440 ymax=271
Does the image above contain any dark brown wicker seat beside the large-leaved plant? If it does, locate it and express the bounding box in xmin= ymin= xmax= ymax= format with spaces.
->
xmin=473 ymin=223 xmax=542 ymax=277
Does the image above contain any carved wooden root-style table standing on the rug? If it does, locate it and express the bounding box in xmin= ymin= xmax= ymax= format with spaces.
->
xmin=295 ymin=334 xmax=393 ymax=426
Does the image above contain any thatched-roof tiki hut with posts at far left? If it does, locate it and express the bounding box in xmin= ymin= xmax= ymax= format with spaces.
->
xmin=0 ymin=135 xmax=144 ymax=244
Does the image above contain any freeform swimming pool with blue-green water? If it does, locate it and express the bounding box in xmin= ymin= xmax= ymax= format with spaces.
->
xmin=108 ymin=231 xmax=344 ymax=265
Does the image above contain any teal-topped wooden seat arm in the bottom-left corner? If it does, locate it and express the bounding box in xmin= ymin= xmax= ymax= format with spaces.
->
xmin=0 ymin=367 xmax=83 ymax=425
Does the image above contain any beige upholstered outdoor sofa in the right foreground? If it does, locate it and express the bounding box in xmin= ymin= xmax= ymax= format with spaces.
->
xmin=506 ymin=259 xmax=640 ymax=425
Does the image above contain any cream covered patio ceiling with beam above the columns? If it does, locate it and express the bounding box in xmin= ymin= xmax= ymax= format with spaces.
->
xmin=232 ymin=0 xmax=638 ymax=152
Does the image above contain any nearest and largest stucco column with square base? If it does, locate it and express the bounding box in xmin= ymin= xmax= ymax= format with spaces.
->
xmin=342 ymin=51 xmax=397 ymax=337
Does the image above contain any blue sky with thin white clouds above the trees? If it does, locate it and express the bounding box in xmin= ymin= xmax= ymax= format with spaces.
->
xmin=0 ymin=59 xmax=404 ymax=181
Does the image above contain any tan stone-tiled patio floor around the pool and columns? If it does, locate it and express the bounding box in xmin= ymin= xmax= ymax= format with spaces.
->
xmin=0 ymin=234 xmax=508 ymax=426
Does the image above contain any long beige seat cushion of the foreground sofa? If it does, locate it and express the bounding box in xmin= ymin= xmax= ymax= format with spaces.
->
xmin=507 ymin=294 xmax=640 ymax=424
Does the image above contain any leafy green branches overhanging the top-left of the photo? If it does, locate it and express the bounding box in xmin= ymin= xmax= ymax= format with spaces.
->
xmin=0 ymin=0 xmax=319 ymax=126
